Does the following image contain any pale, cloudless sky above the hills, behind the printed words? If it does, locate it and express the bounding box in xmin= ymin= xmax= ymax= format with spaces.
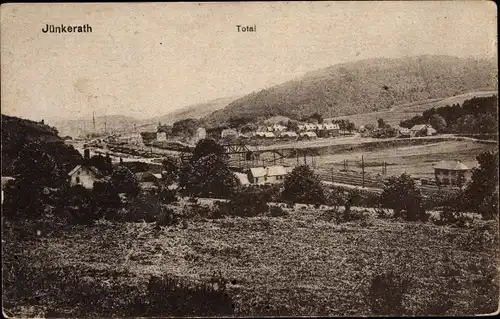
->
xmin=0 ymin=1 xmax=497 ymax=120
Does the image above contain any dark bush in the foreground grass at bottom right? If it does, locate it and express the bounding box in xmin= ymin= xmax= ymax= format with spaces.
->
xmin=366 ymin=271 xmax=410 ymax=316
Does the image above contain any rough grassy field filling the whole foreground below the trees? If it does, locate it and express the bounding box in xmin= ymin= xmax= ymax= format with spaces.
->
xmin=2 ymin=207 xmax=499 ymax=317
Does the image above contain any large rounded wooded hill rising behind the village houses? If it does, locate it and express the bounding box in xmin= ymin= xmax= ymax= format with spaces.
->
xmin=204 ymin=55 xmax=498 ymax=126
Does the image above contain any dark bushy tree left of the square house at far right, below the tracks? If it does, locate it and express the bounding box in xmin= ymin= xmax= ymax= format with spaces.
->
xmin=381 ymin=174 xmax=426 ymax=221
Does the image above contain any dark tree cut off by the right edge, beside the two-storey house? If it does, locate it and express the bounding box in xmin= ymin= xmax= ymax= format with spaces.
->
xmin=465 ymin=151 xmax=498 ymax=219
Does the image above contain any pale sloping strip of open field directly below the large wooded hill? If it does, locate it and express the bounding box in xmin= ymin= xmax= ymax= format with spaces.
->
xmin=335 ymin=91 xmax=498 ymax=126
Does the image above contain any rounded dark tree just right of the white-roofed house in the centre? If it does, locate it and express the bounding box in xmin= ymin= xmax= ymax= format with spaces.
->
xmin=282 ymin=165 xmax=326 ymax=204
